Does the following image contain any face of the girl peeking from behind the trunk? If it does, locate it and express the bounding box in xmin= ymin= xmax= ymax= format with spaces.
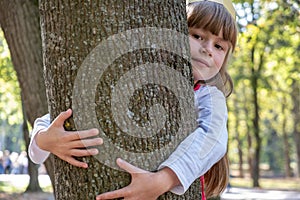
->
xmin=189 ymin=28 xmax=230 ymax=82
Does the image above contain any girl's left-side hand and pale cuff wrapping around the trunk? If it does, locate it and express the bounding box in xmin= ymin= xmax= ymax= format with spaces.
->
xmin=29 ymin=109 xmax=102 ymax=168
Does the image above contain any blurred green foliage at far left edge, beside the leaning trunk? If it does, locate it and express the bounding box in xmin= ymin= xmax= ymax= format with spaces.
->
xmin=0 ymin=30 xmax=25 ymax=152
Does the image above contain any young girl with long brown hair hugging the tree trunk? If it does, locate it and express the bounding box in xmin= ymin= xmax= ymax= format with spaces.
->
xmin=29 ymin=0 xmax=237 ymax=199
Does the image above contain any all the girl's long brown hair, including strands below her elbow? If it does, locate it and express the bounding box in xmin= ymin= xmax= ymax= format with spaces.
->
xmin=187 ymin=1 xmax=238 ymax=197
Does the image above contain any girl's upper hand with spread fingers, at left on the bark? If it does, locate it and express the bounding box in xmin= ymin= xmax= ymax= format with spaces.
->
xmin=35 ymin=109 xmax=103 ymax=168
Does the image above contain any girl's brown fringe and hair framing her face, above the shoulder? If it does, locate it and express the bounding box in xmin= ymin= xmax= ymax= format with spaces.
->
xmin=187 ymin=1 xmax=238 ymax=97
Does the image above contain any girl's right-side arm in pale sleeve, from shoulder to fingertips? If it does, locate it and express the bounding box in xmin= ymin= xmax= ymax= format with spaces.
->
xmin=97 ymin=86 xmax=228 ymax=200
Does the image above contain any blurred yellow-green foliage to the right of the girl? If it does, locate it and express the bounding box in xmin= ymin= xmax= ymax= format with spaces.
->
xmin=228 ymin=0 xmax=300 ymax=178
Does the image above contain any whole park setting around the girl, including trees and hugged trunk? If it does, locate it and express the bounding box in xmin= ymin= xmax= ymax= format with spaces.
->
xmin=0 ymin=0 xmax=300 ymax=200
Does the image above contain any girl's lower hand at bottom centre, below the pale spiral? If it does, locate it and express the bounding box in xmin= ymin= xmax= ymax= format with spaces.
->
xmin=96 ymin=158 xmax=180 ymax=200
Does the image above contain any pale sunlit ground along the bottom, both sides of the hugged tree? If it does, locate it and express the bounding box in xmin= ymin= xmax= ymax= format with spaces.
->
xmin=0 ymin=174 xmax=300 ymax=200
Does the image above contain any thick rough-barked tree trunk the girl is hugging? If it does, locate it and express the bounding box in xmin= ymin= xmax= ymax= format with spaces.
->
xmin=40 ymin=0 xmax=201 ymax=199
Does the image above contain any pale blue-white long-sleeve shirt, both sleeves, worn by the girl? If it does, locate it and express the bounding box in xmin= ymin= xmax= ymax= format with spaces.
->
xmin=29 ymin=86 xmax=228 ymax=194
